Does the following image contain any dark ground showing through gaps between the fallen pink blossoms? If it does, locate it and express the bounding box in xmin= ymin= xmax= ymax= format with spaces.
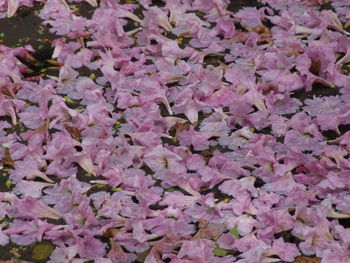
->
xmin=0 ymin=0 xmax=350 ymax=263
